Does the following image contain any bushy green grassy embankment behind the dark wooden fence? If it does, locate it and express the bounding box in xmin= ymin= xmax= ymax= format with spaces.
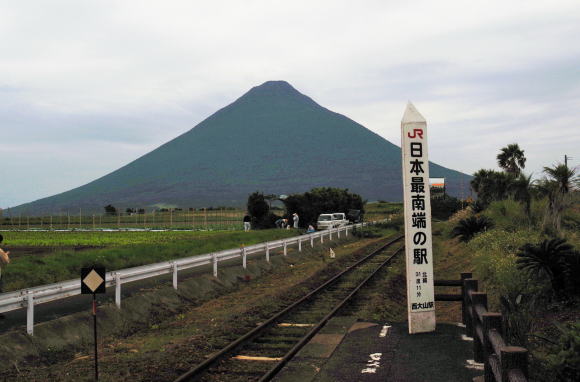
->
xmin=434 ymin=195 xmax=580 ymax=381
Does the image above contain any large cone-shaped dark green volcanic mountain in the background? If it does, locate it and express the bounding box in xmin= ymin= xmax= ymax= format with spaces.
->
xmin=14 ymin=81 xmax=469 ymax=215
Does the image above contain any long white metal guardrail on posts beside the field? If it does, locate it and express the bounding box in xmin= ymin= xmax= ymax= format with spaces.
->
xmin=0 ymin=222 xmax=374 ymax=335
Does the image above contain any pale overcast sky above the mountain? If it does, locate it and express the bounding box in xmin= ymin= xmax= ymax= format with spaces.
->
xmin=0 ymin=0 xmax=580 ymax=207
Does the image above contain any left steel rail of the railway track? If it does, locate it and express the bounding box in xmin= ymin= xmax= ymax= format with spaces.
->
xmin=174 ymin=235 xmax=404 ymax=382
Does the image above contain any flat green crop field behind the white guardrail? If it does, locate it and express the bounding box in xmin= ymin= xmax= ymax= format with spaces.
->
xmin=2 ymin=229 xmax=298 ymax=292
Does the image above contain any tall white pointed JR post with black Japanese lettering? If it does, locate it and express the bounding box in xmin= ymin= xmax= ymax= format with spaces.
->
xmin=401 ymin=102 xmax=435 ymax=334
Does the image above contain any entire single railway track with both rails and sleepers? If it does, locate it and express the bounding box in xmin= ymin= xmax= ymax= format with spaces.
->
xmin=175 ymin=236 xmax=403 ymax=382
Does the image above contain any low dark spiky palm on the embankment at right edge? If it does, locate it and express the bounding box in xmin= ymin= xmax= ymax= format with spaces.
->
xmin=516 ymin=239 xmax=574 ymax=294
